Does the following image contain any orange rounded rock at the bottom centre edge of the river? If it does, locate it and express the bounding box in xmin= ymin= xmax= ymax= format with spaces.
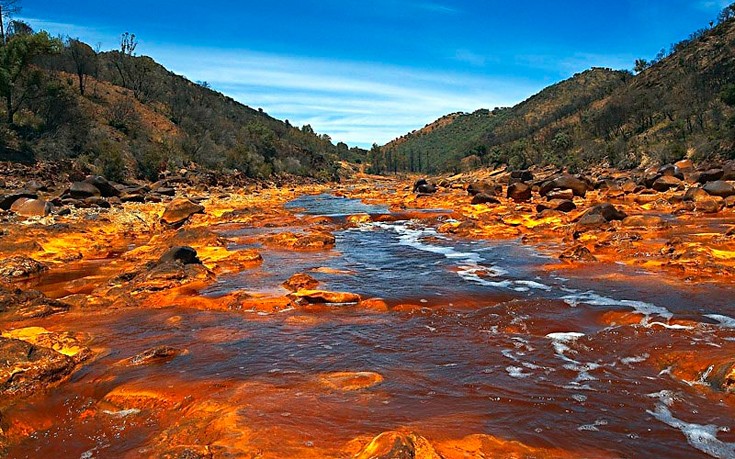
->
xmin=354 ymin=432 xmax=443 ymax=459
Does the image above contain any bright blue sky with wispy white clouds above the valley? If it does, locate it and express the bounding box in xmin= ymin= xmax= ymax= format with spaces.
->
xmin=20 ymin=0 xmax=731 ymax=146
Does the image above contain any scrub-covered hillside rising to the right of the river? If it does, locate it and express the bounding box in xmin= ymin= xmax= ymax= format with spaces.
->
xmin=380 ymin=9 xmax=735 ymax=173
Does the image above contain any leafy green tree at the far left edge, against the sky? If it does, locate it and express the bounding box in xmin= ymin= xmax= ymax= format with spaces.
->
xmin=0 ymin=32 xmax=62 ymax=125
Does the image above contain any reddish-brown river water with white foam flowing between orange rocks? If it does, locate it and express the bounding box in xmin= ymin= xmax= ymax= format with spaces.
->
xmin=6 ymin=195 xmax=735 ymax=458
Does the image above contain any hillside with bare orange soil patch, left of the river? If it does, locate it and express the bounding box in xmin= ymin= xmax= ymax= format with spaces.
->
xmin=0 ymin=26 xmax=348 ymax=180
